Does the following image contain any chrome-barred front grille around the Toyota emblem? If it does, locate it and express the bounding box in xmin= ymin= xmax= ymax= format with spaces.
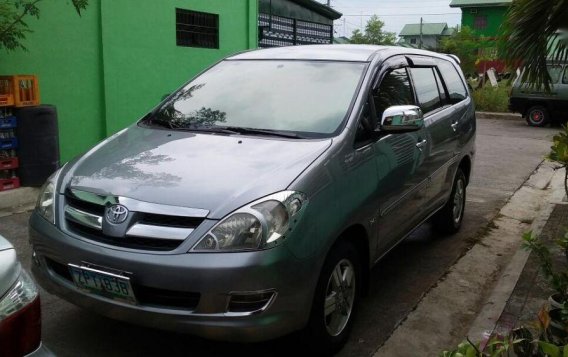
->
xmin=64 ymin=190 xmax=209 ymax=251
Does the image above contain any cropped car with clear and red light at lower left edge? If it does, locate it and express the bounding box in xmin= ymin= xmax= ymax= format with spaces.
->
xmin=0 ymin=235 xmax=53 ymax=357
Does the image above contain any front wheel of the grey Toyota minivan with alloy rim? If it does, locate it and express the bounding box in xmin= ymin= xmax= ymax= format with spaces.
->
xmin=304 ymin=241 xmax=362 ymax=356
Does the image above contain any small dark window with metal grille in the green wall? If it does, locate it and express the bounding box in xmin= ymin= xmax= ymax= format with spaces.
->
xmin=176 ymin=9 xmax=219 ymax=48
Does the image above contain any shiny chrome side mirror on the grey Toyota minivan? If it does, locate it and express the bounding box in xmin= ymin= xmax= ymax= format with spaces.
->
xmin=379 ymin=105 xmax=424 ymax=134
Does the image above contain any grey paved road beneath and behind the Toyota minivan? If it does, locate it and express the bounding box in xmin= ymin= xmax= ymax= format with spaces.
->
xmin=0 ymin=120 xmax=558 ymax=356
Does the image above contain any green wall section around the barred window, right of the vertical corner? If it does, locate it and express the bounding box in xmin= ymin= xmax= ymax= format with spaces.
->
xmin=102 ymin=0 xmax=258 ymax=134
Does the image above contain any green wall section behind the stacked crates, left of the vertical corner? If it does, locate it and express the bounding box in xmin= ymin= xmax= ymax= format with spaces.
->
xmin=0 ymin=1 xmax=105 ymax=161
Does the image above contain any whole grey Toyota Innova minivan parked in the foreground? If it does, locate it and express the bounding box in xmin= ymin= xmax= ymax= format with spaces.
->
xmin=30 ymin=45 xmax=476 ymax=352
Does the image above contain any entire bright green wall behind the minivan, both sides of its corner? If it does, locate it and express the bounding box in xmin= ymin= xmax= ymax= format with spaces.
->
xmin=0 ymin=0 xmax=258 ymax=161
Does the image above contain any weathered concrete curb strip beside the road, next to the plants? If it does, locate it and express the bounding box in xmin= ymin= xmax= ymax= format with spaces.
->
xmin=374 ymin=161 xmax=563 ymax=357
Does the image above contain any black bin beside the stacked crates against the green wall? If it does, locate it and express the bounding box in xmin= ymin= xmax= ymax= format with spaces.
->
xmin=15 ymin=105 xmax=59 ymax=187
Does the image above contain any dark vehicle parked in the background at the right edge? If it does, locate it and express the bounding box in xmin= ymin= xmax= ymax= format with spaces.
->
xmin=509 ymin=63 xmax=568 ymax=127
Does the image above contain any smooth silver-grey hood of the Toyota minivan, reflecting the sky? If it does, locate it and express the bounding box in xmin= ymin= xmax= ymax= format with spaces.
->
xmin=60 ymin=126 xmax=331 ymax=219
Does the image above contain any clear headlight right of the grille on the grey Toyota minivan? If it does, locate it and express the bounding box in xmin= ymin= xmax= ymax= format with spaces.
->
xmin=192 ymin=191 xmax=308 ymax=252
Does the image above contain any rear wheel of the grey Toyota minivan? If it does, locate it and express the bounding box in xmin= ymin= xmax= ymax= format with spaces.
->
xmin=432 ymin=168 xmax=467 ymax=234
